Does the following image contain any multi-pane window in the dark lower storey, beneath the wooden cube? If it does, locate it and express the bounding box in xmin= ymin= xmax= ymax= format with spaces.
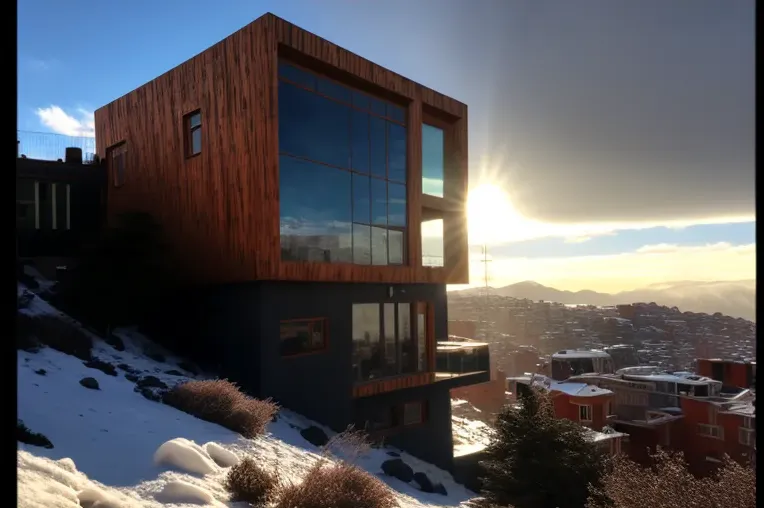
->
xmin=353 ymin=303 xmax=426 ymax=382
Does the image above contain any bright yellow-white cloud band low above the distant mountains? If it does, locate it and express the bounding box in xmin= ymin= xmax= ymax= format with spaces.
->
xmin=456 ymin=242 xmax=756 ymax=293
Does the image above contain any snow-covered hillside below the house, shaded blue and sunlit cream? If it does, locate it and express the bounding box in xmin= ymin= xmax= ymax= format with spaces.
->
xmin=17 ymin=278 xmax=475 ymax=508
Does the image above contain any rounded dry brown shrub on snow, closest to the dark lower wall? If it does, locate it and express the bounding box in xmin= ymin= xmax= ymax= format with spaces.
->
xmin=163 ymin=379 xmax=278 ymax=438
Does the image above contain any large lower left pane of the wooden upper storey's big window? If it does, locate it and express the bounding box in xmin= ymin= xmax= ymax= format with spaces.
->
xmin=279 ymin=155 xmax=352 ymax=262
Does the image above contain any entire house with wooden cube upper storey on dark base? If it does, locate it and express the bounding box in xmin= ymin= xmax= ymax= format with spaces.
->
xmin=95 ymin=14 xmax=489 ymax=468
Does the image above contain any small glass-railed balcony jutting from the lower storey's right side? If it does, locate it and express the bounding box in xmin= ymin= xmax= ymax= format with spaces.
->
xmin=435 ymin=341 xmax=491 ymax=388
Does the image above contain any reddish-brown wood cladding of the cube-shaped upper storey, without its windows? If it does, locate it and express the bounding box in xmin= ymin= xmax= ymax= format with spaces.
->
xmin=95 ymin=14 xmax=469 ymax=284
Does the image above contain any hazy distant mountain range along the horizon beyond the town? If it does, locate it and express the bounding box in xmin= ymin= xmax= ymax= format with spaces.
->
xmin=455 ymin=280 xmax=756 ymax=321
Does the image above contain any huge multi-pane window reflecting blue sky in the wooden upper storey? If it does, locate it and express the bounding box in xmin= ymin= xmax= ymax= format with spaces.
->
xmin=278 ymin=62 xmax=407 ymax=265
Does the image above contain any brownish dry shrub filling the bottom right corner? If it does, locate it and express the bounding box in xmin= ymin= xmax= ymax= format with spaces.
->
xmin=587 ymin=450 xmax=756 ymax=508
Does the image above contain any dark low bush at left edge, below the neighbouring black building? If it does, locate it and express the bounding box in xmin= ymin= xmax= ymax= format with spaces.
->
xmin=16 ymin=312 xmax=93 ymax=360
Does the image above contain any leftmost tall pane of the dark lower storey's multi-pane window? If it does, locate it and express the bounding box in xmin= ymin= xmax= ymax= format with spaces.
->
xmin=353 ymin=303 xmax=383 ymax=381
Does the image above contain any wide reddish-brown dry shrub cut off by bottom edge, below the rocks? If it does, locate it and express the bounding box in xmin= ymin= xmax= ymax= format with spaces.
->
xmin=276 ymin=460 xmax=398 ymax=508
